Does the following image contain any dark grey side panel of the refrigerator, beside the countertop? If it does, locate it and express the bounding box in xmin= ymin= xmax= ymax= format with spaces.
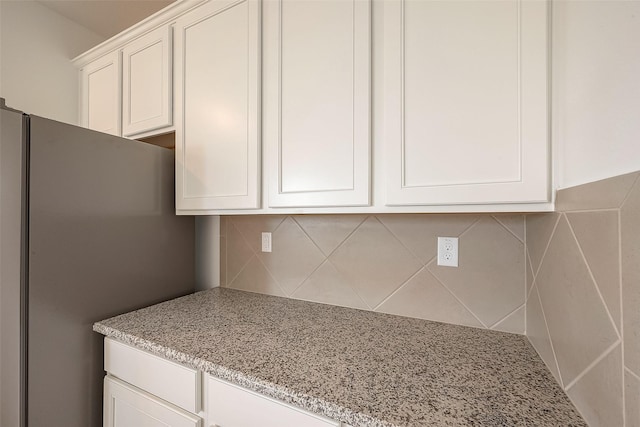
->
xmin=25 ymin=116 xmax=195 ymax=427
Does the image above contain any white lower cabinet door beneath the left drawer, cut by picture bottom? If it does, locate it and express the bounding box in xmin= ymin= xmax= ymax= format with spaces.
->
xmin=104 ymin=377 xmax=202 ymax=427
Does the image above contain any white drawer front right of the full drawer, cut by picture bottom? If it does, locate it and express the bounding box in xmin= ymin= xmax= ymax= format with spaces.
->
xmin=207 ymin=377 xmax=340 ymax=427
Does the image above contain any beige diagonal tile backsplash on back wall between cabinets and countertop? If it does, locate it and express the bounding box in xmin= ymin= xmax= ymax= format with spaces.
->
xmin=220 ymin=214 xmax=526 ymax=334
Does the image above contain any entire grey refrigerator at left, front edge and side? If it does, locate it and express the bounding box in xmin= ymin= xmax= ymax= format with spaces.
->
xmin=0 ymin=103 xmax=195 ymax=427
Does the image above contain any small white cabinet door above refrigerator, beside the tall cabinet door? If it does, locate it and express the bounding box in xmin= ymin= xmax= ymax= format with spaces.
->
xmin=122 ymin=25 xmax=172 ymax=136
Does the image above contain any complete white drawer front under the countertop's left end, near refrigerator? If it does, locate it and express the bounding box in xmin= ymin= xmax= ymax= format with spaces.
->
xmin=104 ymin=338 xmax=201 ymax=413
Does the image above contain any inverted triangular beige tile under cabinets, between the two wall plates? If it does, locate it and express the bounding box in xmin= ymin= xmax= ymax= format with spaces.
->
xmin=293 ymin=215 xmax=366 ymax=256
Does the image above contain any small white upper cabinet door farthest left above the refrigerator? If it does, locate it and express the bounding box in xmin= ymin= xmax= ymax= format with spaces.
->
xmin=80 ymin=51 xmax=122 ymax=136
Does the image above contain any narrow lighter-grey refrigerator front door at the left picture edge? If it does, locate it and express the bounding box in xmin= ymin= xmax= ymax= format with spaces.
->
xmin=0 ymin=108 xmax=23 ymax=426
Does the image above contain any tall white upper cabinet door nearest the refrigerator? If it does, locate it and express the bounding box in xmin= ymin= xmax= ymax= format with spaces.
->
xmin=175 ymin=0 xmax=261 ymax=210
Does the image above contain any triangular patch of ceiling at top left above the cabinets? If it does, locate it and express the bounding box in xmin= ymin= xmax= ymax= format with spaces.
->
xmin=37 ymin=0 xmax=175 ymax=39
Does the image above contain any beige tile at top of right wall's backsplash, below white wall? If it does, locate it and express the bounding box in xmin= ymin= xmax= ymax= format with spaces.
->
xmin=556 ymin=172 xmax=639 ymax=212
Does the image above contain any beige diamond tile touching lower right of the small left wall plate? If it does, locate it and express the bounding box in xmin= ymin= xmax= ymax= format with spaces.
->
xmin=258 ymin=217 xmax=326 ymax=295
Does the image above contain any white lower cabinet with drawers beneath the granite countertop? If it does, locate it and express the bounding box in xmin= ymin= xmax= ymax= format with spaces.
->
xmin=103 ymin=338 xmax=348 ymax=427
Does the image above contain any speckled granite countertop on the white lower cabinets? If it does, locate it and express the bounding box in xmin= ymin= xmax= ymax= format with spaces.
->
xmin=93 ymin=288 xmax=586 ymax=427
